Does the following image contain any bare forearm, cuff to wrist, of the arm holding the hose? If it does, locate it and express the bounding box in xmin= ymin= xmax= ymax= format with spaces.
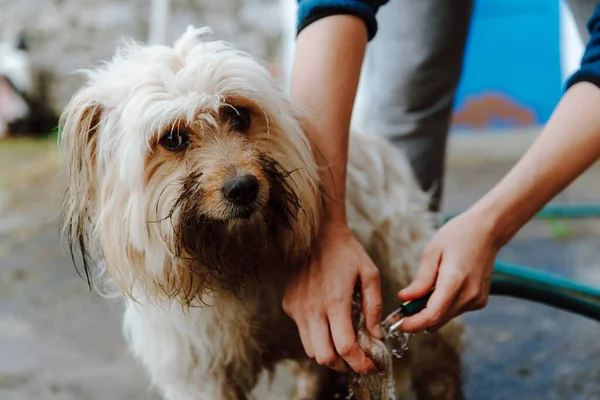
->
xmin=472 ymin=82 xmax=600 ymax=246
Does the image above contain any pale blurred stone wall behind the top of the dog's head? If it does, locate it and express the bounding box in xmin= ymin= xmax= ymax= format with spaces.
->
xmin=0 ymin=0 xmax=282 ymax=111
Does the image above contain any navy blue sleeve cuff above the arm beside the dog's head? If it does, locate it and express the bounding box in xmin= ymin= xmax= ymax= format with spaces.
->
xmin=298 ymin=0 xmax=390 ymax=40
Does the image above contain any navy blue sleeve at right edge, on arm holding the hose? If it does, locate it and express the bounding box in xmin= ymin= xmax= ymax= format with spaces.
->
xmin=566 ymin=5 xmax=600 ymax=89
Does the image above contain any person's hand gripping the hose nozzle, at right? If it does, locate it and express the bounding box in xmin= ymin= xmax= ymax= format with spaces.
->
xmin=398 ymin=211 xmax=500 ymax=333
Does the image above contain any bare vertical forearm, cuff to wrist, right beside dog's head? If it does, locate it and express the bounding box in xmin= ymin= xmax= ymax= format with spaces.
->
xmin=291 ymin=15 xmax=367 ymax=222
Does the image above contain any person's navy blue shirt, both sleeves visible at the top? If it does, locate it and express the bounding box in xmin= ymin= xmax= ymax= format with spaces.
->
xmin=298 ymin=0 xmax=600 ymax=89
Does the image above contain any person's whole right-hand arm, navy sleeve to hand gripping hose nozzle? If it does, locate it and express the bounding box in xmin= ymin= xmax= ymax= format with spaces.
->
xmin=399 ymin=6 xmax=600 ymax=332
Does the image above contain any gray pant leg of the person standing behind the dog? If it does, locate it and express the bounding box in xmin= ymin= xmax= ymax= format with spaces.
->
xmin=366 ymin=0 xmax=472 ymax=211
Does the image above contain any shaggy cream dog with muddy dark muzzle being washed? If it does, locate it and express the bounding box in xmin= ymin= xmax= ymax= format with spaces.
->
xmin=60 ymin=27 xmax=462 ymax=400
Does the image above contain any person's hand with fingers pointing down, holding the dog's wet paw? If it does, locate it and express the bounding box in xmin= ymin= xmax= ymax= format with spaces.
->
xmin=283 ymin=223 xmax=383 ymax=374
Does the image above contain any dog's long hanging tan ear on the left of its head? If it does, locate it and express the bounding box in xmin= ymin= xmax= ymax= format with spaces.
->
xmin=59 ymin=89 xmax=104 ymax=285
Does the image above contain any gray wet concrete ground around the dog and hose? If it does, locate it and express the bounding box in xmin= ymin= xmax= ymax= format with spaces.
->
xmin=0 ymin=132 xmax=600 ymax=400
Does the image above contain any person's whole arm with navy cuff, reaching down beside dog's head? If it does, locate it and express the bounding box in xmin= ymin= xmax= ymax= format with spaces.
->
xmin=283 ymin=0 xmax=385 ymax=373
